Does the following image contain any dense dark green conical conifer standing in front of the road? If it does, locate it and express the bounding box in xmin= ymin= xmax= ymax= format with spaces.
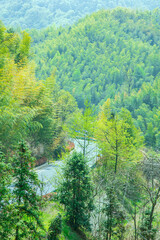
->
xmin=58 ymin=152 xmax=93 ymax=230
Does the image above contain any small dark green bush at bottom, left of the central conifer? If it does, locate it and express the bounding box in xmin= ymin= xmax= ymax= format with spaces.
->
xmin=48 ymin=214 xmax=62 ymax=240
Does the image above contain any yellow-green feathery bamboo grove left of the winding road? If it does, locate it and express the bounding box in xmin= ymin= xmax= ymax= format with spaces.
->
xmin=0 ymin=23 xmax=77 ymax=157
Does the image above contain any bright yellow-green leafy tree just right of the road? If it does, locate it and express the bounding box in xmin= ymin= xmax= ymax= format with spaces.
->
xmin=96 ymin=99 xmax=143 ymax=173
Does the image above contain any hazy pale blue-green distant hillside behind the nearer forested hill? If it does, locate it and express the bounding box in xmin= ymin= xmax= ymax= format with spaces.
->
xmin=0 ymin=0 xmax=160 ymax=29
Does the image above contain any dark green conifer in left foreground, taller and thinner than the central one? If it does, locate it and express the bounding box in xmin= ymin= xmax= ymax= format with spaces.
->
xmin=13 ymin=141 xmax=43 ymax=240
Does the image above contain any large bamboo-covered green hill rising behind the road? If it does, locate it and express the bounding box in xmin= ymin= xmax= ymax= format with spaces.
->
xmin=31 ymin=8 xmax=160 ymax=148
